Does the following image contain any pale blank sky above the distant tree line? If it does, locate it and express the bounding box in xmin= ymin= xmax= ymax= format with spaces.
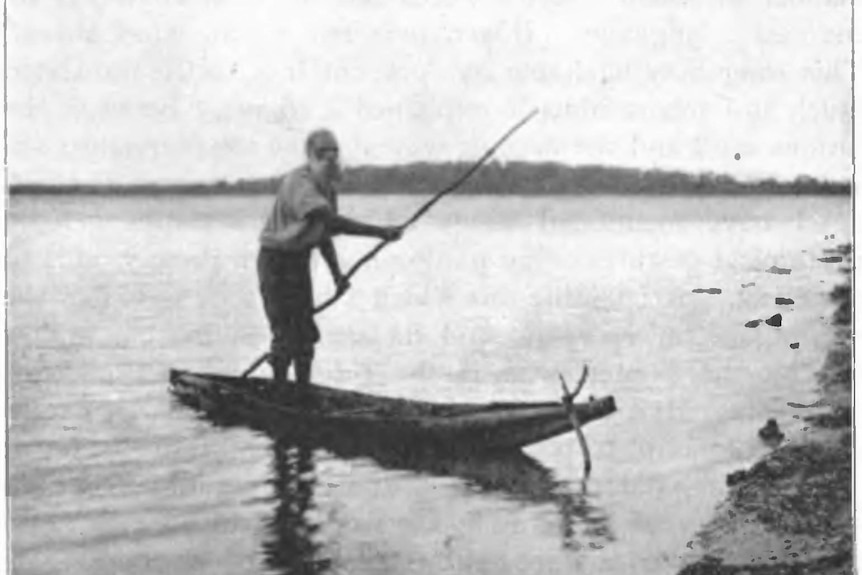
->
xmin=7 ymin=0 xmax=852 ymax=184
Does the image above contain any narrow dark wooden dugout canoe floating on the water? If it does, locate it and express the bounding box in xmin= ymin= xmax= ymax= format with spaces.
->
xmin=170 ymin=370 xmax=616 ymax=452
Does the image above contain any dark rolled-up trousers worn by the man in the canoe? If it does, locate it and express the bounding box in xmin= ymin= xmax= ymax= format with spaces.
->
xmin=257 ymin=248 xmax=320 ymax=370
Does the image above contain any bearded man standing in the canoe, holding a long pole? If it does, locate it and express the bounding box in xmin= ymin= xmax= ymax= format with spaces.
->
xmin=257 ymin=130 xmax=401 ymax=392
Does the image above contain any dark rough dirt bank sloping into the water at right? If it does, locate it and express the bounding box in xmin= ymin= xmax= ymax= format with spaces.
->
xmin=680 ymin=246 xmax=853 ymax=575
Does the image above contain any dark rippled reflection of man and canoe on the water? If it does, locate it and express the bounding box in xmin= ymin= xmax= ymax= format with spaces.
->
xmin=260 ymin=438 xmax=615 ymax=575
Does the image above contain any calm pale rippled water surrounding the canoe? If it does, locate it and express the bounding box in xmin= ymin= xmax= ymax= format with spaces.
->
xmin=8 ymin=192 xmax=850 ymax=575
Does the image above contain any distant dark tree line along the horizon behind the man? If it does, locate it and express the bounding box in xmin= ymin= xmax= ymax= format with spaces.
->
xmin=9 ymin=161 xmax=850 ymax=195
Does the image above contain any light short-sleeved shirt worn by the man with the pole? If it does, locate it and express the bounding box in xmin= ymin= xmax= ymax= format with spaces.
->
xmin=260 ymin=166 xmax=337 ymax=252
